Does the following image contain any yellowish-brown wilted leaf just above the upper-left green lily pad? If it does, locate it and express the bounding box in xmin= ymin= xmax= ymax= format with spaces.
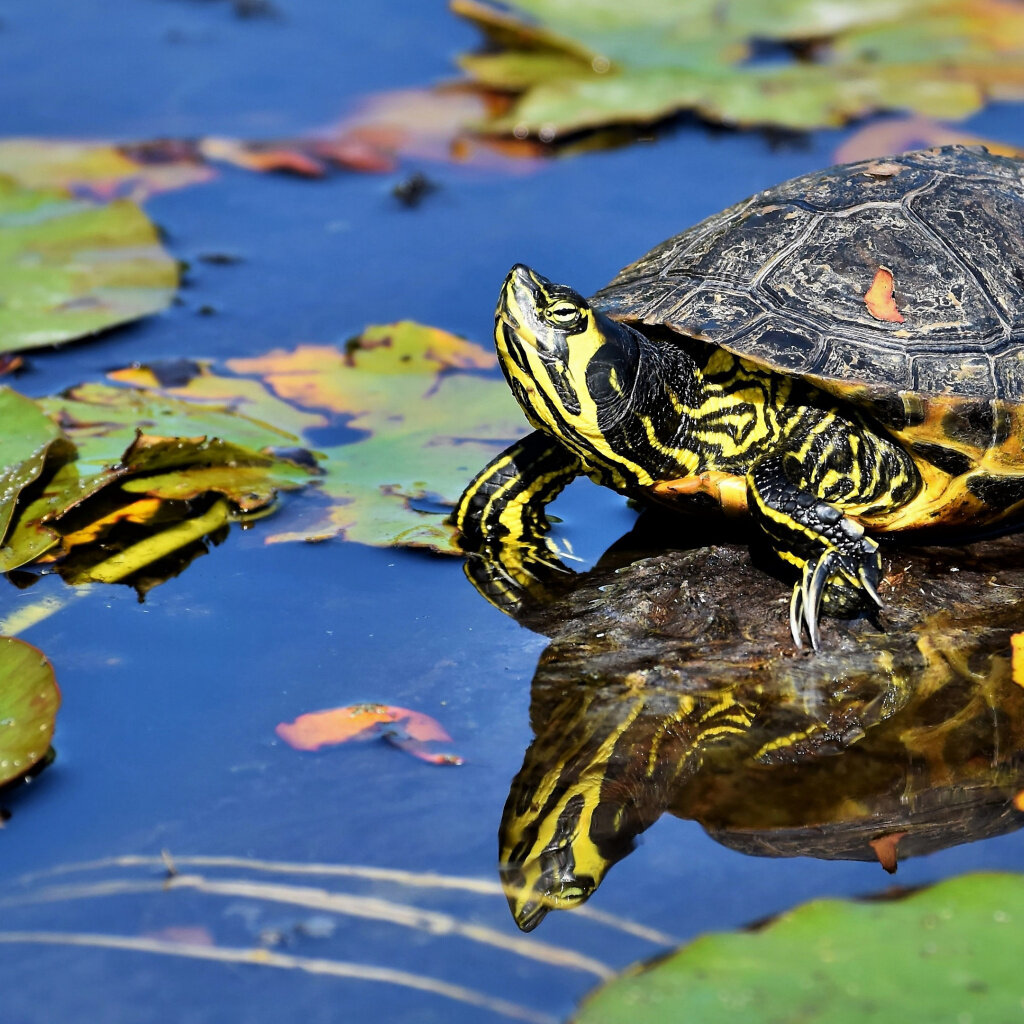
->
xmin=0 ymin=138 xmax=215 ymax=203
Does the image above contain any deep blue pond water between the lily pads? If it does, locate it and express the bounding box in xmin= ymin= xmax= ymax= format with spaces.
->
xmin=6 ymin=0 xmax=1024 ymax=1024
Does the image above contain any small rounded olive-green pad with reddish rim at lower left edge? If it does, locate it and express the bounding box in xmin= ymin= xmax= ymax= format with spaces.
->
xmin=0 ymin=637 xmax=60 ymax=785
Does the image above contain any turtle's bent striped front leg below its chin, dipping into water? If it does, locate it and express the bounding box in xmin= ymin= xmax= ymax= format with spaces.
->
xmin=452 ymin=430 xmax=584 ymax=617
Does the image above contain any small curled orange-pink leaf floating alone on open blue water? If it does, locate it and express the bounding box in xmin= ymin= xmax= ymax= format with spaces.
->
xmin=274 ymin=703 xmax=463 ymax=765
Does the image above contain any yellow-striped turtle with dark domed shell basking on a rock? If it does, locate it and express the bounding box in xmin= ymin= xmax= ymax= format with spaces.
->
xmin=453 ymin=146 xmax=1024 ymax=650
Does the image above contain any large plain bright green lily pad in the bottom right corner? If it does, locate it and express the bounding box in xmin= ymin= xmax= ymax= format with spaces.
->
xmin=573 ymin=874 xmax=1024 ymax=1024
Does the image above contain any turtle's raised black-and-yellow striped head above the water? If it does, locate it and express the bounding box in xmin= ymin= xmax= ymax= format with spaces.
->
xmin=495 ymin=263 xmax=643 ymax=461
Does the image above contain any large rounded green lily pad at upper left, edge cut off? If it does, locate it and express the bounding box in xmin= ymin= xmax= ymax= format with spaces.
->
xmin=0 ymin=177 xmax=178 ymax=352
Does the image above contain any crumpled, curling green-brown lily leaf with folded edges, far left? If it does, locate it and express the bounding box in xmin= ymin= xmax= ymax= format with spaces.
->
xmin=0 ymin=384 xmax=316 ymax=583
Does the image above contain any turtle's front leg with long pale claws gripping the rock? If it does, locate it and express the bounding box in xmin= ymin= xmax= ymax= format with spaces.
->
xmin=746 ymin=453 xmax=888 ymax=650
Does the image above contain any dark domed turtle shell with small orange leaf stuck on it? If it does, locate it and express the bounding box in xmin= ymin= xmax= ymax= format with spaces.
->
xmin=593 ymin=146 xmax=1024 ymax=460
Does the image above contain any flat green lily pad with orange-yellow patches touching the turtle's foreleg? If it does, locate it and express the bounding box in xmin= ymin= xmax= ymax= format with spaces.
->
xmin=128 ymin=322 xmax=524 ymax=553
